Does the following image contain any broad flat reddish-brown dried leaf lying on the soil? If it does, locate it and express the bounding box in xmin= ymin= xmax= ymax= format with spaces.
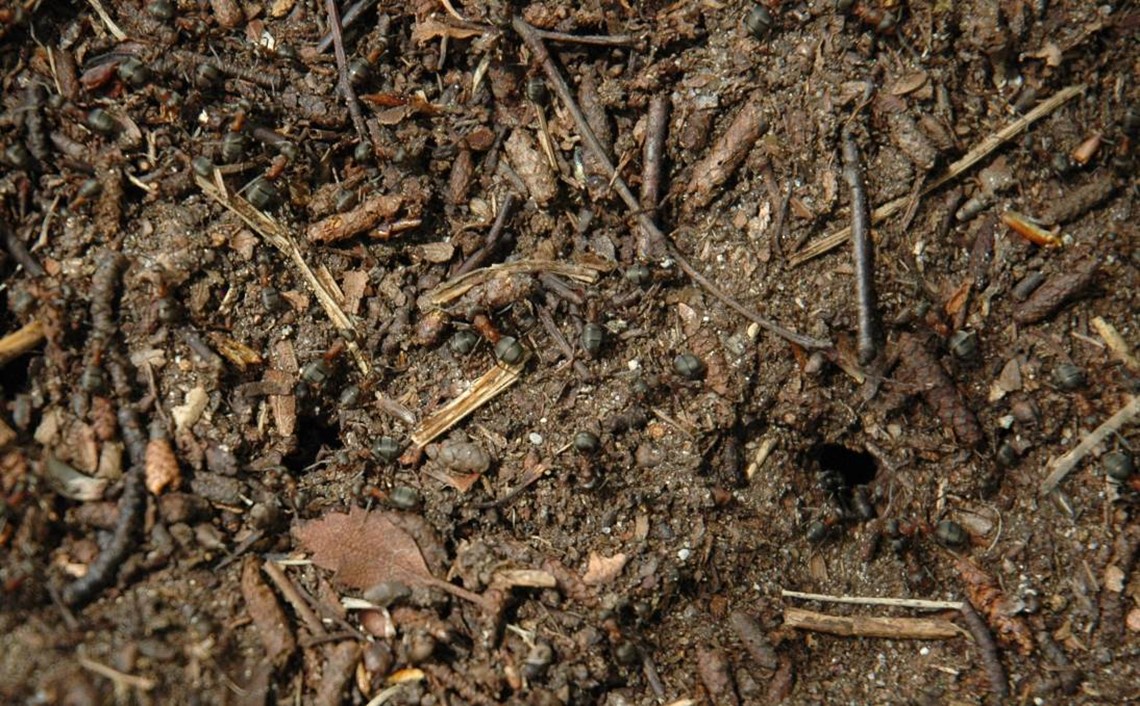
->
xmin=294 ymin=508 xmax=441 ymax=589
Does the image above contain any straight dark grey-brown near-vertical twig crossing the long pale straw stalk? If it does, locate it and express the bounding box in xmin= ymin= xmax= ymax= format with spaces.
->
xmin=842 ymin=128 xmax=879 ymax=365
